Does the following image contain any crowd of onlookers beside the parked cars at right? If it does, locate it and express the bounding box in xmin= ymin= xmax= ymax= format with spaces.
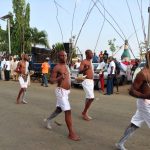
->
xmin=71 ymin=50 xmax=139 ymax=95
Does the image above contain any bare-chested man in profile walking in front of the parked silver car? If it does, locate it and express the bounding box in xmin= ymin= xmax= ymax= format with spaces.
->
xmin=79 ymin=50 xmax=94 ymax=121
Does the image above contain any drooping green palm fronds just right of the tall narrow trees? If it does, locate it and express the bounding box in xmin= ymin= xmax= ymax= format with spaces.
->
xmin=31 ymin=28 xmax=49 ymax=48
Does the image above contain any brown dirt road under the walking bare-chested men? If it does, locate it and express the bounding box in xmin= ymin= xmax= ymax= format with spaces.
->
xmin=0 ymin=81 xmax=150 ymax=150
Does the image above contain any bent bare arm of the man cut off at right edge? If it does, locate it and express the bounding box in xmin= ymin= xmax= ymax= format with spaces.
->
xmin=129 ymin=71 xmax=150 ymax=99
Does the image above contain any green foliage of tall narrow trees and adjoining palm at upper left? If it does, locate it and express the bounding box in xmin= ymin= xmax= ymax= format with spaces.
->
xmin=0 ymin=0 xmax=49 ymax=55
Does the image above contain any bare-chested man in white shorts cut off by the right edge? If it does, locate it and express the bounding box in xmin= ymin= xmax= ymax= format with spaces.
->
xmin=116 ymin=51 xmax=150 ymax=150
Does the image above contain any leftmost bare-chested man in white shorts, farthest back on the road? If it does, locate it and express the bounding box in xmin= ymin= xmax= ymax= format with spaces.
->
xmin=16 ymin=54 xmax=30 ymax=104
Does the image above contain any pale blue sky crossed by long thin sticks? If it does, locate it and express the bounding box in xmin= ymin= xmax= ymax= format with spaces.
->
xmin=0 ymin=0 xmax=150 ymax=59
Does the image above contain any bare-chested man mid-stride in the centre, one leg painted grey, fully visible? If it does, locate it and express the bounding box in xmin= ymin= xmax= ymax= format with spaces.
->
xmin=45 ymin=51 xmax=80 ymax=141
